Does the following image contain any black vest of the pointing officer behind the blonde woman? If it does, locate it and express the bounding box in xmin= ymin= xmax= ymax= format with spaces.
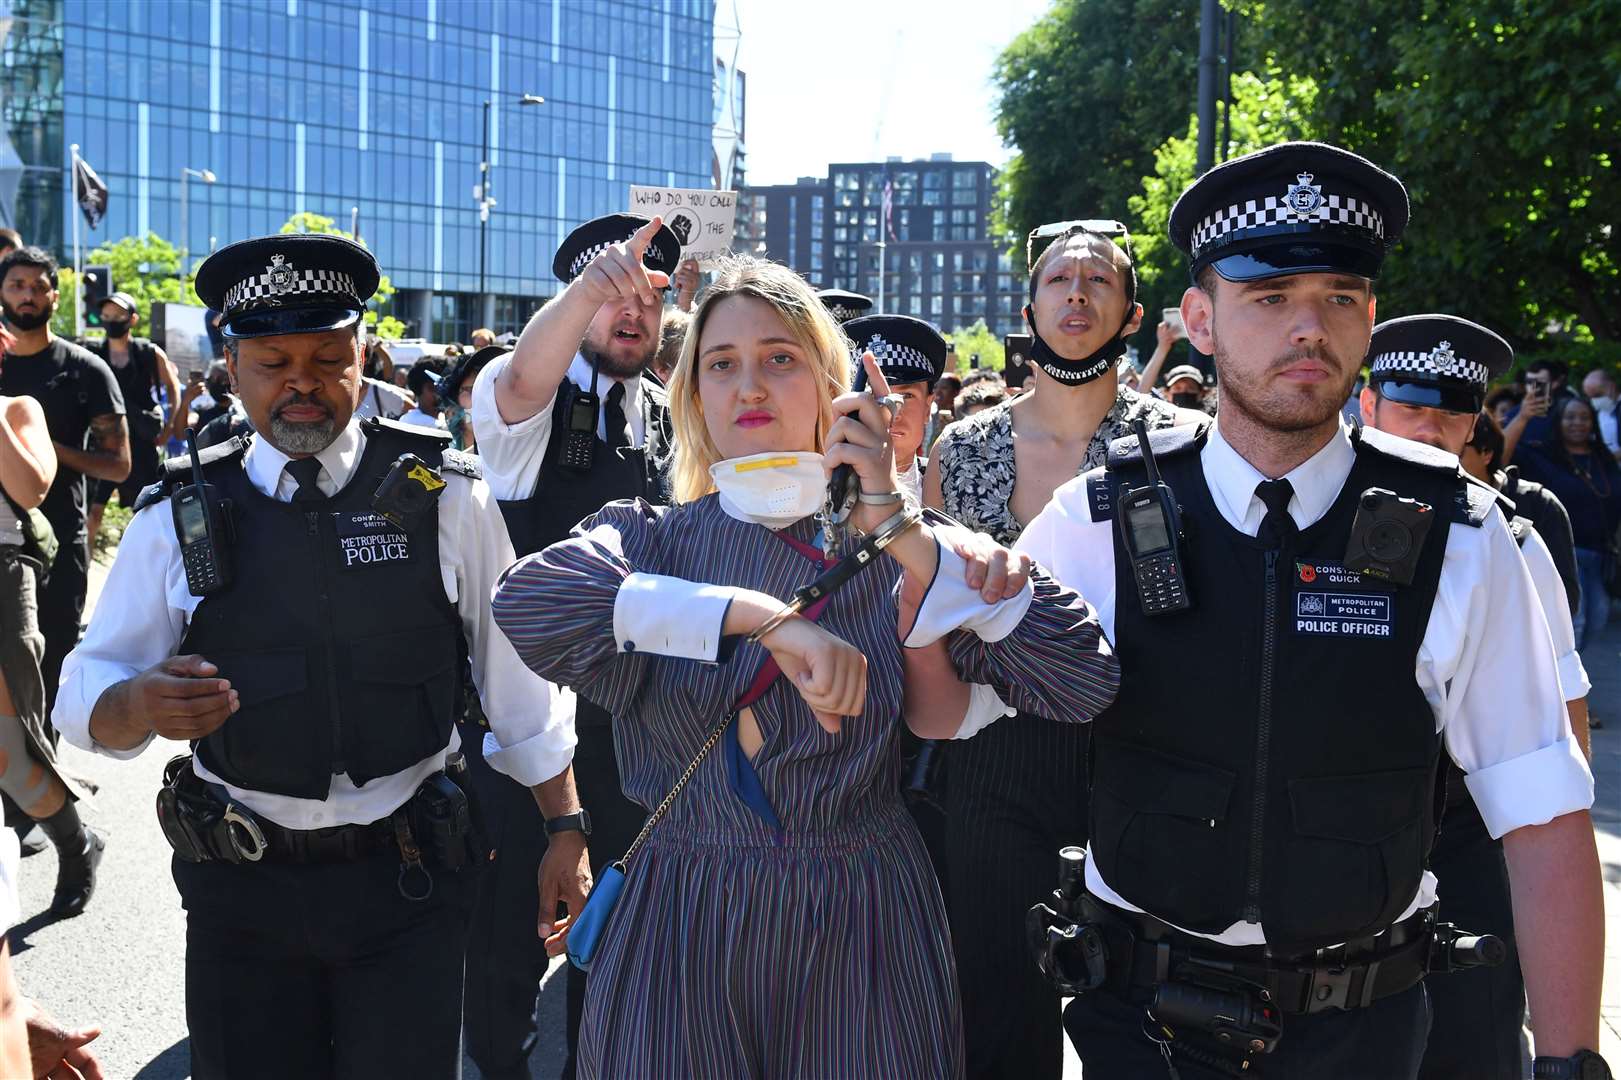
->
xmin=501 ymin=378 xmax=669 ymax=725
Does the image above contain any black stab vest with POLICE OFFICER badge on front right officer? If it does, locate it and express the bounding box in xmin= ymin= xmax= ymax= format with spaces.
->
xmin=1088 ymin=426 xmax=1490 ymax=954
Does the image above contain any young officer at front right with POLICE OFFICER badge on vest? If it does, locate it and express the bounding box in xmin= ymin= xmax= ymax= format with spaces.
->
xmin=953 ymin=143 xmax=1608 ymax=1080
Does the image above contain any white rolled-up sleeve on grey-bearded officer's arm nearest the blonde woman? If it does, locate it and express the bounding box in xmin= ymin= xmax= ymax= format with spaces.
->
xmin=439 ymin=478 xmax=574 ymax=786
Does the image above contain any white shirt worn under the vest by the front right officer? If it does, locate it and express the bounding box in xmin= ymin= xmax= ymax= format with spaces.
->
xmin=963 ymin=418 xmax=1593 ymax=945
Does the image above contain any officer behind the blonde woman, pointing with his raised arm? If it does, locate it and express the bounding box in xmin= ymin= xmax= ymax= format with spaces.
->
xmin=467 ymin=214 xmax=681 ymax=1077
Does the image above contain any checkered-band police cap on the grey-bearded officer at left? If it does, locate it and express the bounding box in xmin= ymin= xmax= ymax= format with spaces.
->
xmin=196 ymin=232 xmax=379 ymax=337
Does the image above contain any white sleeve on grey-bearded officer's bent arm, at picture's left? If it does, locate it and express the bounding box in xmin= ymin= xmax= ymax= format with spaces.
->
xmin=50 ymin=504 xmax=188 ymax=759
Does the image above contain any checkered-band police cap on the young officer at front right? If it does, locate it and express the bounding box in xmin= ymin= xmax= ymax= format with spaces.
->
xmin=1170 ymin=143 xmax=1407 ymax=282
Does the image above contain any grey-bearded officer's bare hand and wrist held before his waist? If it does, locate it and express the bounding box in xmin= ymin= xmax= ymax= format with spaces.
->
xmin=91 ymin=655 xmax=242 ymax=749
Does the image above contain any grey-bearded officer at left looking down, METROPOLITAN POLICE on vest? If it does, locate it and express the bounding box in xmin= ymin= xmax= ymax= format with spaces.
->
xmin=55 ymin=234 xmax=587 ymax=1080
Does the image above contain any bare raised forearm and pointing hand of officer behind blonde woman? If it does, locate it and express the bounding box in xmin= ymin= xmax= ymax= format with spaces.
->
xmin=496 ymin=217 xmax=669 ymax=423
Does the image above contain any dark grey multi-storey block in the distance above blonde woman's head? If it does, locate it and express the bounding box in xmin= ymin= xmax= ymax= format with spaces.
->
xmin=739 ymin=154 xmax=1026 ymax=334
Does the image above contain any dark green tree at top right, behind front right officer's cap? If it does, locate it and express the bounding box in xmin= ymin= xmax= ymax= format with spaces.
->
xmin=1238 ymin=0 xmax=1621 ymax=340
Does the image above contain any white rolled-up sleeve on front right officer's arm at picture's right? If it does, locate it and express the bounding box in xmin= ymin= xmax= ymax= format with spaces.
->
xmin=1418 ymin=511 xmax=1593 ymax=837
